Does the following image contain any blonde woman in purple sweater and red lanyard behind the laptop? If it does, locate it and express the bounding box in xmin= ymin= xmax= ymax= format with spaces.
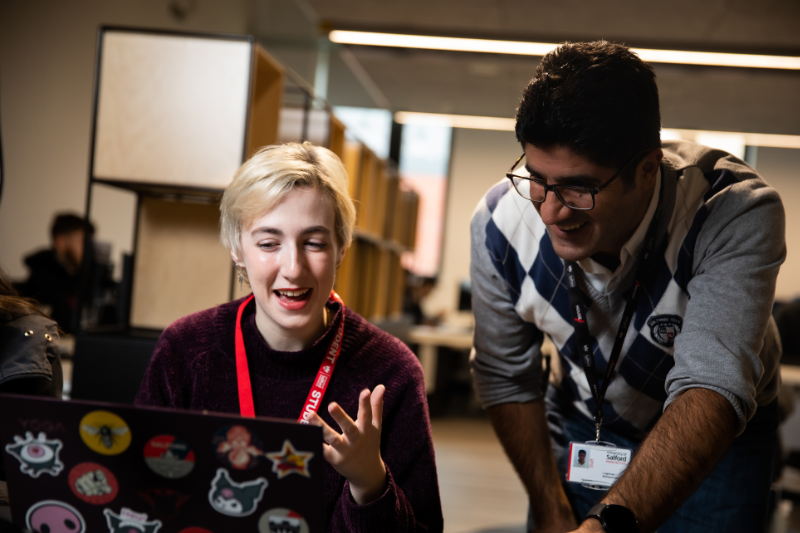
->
xmin=137 ymin=143 xmax=443 ymax=533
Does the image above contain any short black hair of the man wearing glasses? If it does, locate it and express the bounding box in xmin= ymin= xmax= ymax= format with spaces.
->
xmin=515 ymin=41 xmax=661 ymax=182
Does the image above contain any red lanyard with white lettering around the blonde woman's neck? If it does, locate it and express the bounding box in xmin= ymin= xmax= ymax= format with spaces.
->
xmin=235 ymin=291 xmax=344 ymax=424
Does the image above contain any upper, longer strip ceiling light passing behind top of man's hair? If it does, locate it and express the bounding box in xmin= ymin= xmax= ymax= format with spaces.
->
xmin=328 ymin=30 xmax=800 ymax=70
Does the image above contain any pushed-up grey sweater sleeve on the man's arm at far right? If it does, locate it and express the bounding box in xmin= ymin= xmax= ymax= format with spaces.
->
xmin=664 ymin=165 xmax=786 ymax=434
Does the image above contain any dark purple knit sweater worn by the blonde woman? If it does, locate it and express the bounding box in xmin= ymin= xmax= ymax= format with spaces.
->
xmin=136 ymin=300 xmax=443 ymax=533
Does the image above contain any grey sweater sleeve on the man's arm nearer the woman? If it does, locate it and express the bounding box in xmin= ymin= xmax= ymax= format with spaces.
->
xmin=470 ymin=200 xmax=544 ymax=407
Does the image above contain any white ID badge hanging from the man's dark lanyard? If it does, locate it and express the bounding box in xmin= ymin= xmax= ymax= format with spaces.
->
xmin=567 ymin=441 xmax=633 ymax=490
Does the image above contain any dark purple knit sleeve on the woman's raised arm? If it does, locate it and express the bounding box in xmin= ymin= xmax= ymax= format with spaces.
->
xmin=328 ymin=350 xmax=444 ymax=533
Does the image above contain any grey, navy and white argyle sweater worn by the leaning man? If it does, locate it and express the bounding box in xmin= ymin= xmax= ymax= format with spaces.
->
xmin=471 ymin=141 xmax=786 ymax=438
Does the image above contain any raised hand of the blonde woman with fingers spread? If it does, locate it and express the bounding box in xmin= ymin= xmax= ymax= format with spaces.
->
xmin=311 ymin=385 xmax=386 ymax=505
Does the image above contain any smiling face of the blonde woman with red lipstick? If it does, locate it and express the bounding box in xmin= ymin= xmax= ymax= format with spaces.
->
xmin=234 ymin=188 xmax=344 ymax=351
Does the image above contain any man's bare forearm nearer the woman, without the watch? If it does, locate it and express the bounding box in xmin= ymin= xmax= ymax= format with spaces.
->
xmin=488 ymin=398 xmax=577 ymax=533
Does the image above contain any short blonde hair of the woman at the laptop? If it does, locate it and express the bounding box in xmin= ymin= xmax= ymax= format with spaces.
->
xmin=220 ymin=142 xmax=356 ymax=258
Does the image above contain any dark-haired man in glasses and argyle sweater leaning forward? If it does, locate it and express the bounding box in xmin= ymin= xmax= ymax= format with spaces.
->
xmin=471 ymin=41 xmax=786 ymax=533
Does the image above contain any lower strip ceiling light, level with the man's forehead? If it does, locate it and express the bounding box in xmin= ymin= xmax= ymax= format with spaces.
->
xmin=394 ymin=111 xmax=800 ymax=149
